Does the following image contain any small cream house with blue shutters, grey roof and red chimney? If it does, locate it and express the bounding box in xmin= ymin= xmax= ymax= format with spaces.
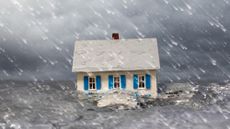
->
xmin=72 ymin=33 xmax=160 ymax=97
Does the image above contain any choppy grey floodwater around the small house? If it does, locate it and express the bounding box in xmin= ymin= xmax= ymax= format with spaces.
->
xmin=0 ymin=81 xmax=230 ymax=129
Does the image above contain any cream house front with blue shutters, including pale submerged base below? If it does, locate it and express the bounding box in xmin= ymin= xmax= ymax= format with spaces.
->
xmin=76 ymin=70 xmax=157 ymax=108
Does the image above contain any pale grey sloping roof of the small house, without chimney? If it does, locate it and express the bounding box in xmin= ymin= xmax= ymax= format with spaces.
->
xmin=72 ymin=39 xmax=160 ymax=72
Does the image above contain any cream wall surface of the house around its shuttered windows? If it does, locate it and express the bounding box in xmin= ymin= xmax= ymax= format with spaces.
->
xmin=76 ymin=70 xmax=157 ymax=97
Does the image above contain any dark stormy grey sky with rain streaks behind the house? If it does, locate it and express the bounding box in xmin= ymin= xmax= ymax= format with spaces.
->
xmin=0 ymin=0 xmax=230 ymax=82
